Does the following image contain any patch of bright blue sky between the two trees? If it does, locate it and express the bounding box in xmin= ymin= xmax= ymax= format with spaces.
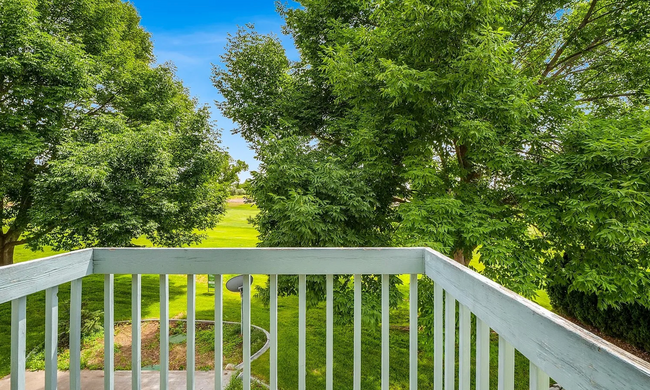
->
xmin=131 ymin=0 xmax=298 ymax=181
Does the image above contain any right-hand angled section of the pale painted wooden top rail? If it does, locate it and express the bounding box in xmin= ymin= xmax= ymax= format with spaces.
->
xmin=425 ymin=249 xmax=650 ymax=390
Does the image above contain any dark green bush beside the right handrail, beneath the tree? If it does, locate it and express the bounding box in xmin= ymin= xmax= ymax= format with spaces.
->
xmin=547 ymin=278 xmax=650 ymax=352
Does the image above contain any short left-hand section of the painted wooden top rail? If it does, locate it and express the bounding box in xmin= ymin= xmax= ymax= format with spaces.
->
xmin=0 ymin=249 xmax=93 ymax=304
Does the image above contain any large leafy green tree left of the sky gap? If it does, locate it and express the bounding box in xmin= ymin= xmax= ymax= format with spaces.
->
xmin=0 ymin=0 xmax=241 ymax=265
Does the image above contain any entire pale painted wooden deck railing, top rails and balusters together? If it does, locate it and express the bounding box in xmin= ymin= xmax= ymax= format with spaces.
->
xmin=0 ymin=248 xmax=650 ymax=390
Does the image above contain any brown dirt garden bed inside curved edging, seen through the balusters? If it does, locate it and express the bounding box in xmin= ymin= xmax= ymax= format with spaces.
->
xmin=82 ymin=320 xmax=266 ymax=371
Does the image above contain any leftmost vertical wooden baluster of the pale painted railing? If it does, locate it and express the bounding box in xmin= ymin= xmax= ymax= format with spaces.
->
xmin=11 ymin=297 xmax=27 ymax=390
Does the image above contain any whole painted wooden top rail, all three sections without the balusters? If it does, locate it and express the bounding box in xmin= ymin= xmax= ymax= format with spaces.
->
xmin=0 ymin=248 xmax=650 ymax=390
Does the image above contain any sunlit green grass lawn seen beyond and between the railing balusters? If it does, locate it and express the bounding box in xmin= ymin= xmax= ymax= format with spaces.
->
xmin=0 ymin=200 xmax=548 ymax=389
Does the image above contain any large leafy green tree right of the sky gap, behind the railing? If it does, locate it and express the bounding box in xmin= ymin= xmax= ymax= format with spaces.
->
xmin=215 ymin=0 xmax=650 ymax=307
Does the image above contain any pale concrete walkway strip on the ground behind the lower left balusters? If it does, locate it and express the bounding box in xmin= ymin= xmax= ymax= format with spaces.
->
xmin=0 ymin=370 xmax=236 ymax=390
